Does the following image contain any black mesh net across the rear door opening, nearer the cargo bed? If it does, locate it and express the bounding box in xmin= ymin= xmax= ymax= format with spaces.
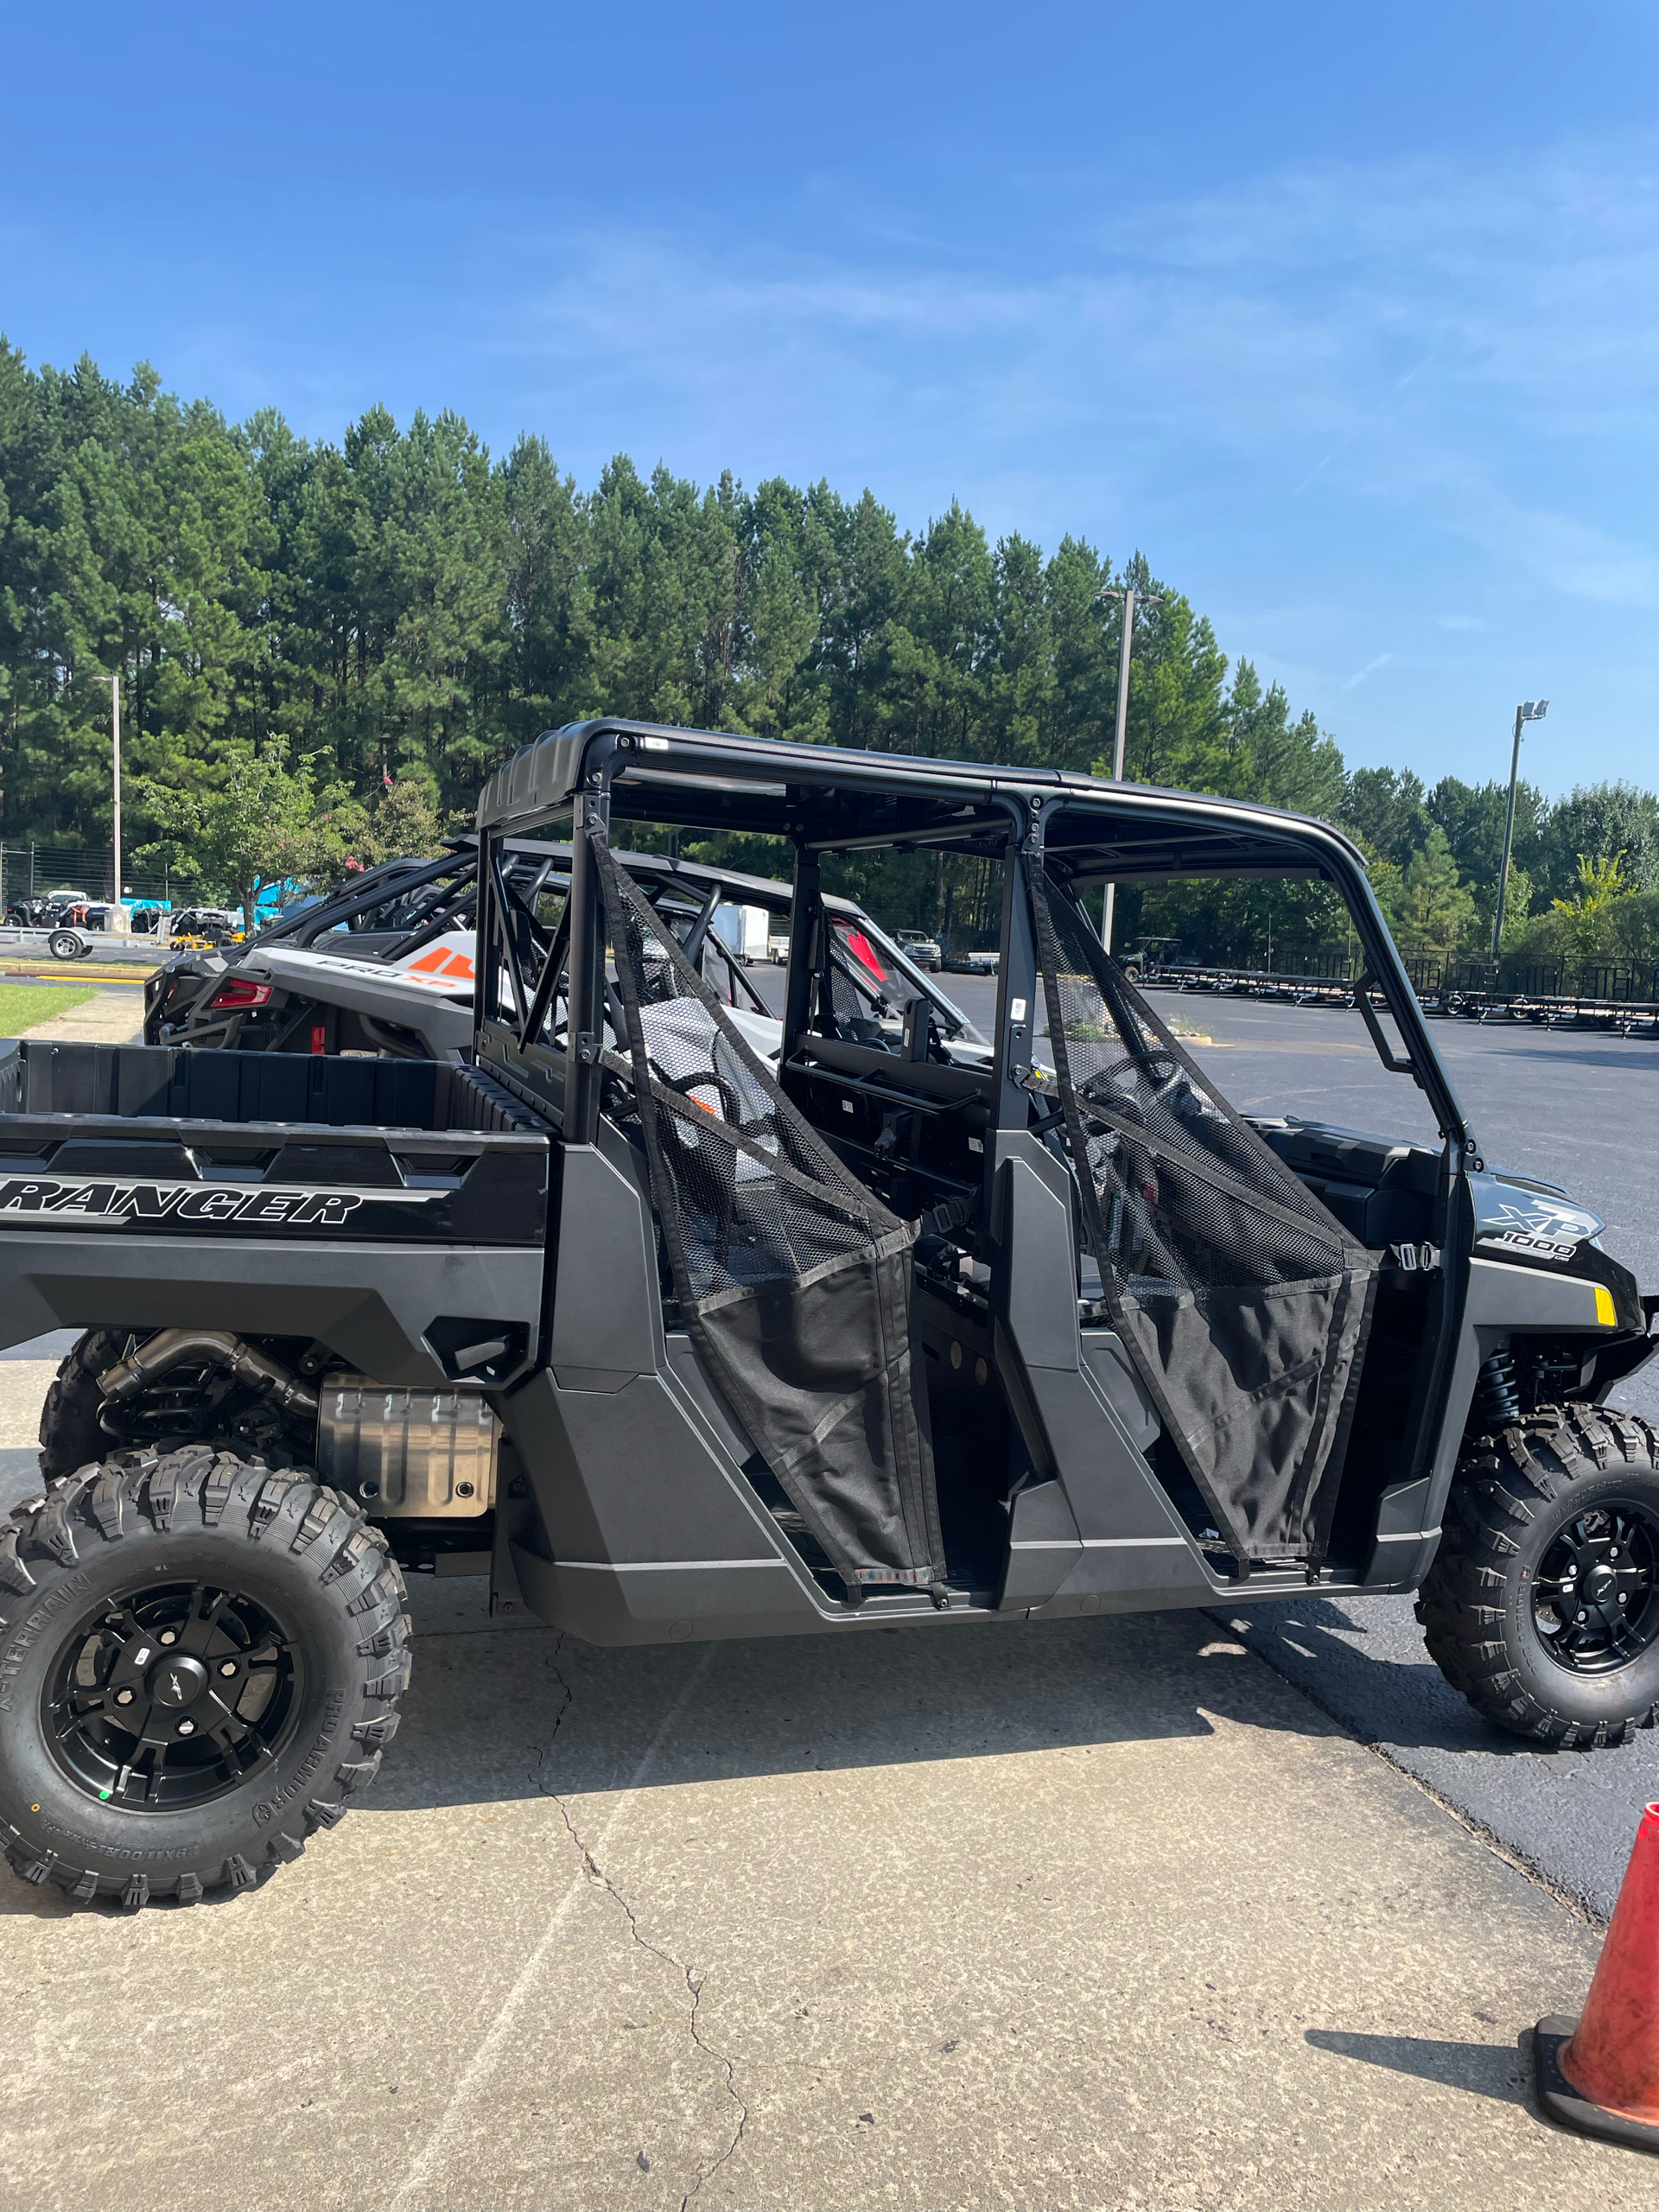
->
xmin=588 ymin=830 xmax=944 ymax=1597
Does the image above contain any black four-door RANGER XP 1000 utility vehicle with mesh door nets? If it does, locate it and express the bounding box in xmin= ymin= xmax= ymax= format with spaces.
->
xmin=0 ymin=721 xmax=1659 ymax=1904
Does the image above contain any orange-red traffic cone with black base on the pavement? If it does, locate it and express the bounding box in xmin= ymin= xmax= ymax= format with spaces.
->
xmin=1533 ymin=1805 xmax=1659 ymax=2150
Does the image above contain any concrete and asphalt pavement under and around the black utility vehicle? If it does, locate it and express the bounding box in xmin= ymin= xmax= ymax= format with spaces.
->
xmin=0 ymin=978 xmax=1659 ymax=2212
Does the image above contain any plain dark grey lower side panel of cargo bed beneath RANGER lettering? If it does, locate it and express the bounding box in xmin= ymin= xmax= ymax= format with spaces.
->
xmin=0 ymin=1224 xmax=542 ymax=1389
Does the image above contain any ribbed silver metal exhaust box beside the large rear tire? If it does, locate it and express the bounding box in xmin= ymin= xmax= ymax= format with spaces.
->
xmin=316 ymin=1376 xmax=500 ymax=1520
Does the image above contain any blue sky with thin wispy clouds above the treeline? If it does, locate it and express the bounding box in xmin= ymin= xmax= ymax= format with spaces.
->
xmin=0 ymin=0 xmax=1659 ymax=791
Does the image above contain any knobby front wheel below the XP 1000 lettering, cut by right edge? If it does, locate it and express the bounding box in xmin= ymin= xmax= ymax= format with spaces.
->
xmin=1418 ymin=1405 xmax=1659 ymax=1750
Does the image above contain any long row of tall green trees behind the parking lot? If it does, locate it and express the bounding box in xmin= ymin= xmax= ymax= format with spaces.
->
xmin=0 ymin=340 xmax=1659 ymax=977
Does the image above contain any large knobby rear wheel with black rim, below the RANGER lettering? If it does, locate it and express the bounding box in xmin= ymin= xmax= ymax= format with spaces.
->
xmin=0 ymin=1445 xmax=410 ymax=1907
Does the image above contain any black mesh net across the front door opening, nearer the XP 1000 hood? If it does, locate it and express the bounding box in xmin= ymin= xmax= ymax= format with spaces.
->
xmin=1031 ymin=868 xmax=1374 ymax=1560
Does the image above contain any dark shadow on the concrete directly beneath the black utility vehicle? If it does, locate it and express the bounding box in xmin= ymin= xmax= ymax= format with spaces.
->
xmin=365 ymin=1592 xmax=1340 ymax=1812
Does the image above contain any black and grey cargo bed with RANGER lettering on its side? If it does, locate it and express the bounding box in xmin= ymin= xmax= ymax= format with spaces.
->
xmin=0 ymin=1038 xmax=550 ymax=1385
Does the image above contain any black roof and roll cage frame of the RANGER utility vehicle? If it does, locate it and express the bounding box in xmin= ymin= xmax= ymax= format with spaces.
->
xmin=478 ymin=719 xmax=1482 ymax=1179
